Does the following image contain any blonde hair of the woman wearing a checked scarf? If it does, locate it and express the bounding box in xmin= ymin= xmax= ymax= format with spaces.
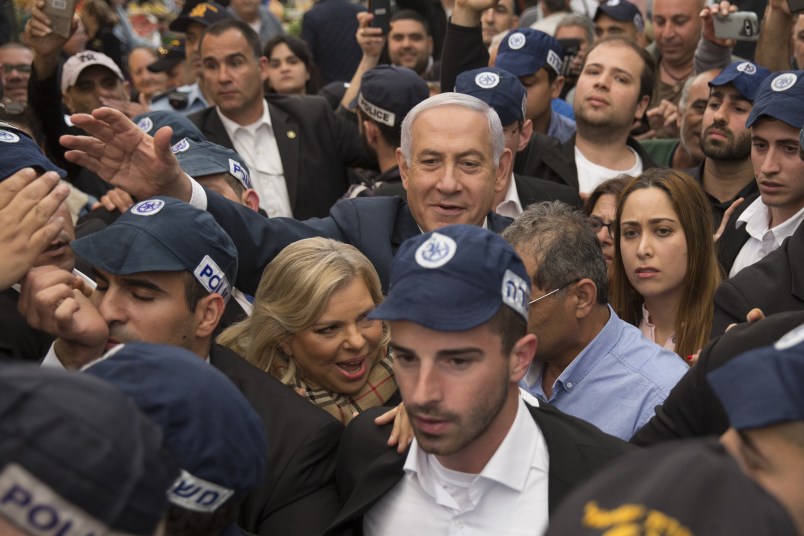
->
xmin=218 ymin=238 xmax=390 ymax=384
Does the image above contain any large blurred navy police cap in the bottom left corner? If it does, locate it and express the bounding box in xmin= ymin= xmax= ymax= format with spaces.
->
xmin=0 ymin=365 xmax=179 ymax=535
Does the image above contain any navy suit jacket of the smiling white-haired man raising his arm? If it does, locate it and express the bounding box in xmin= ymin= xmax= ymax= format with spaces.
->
xmin=206 ymin=190 xmax=511 ymax=295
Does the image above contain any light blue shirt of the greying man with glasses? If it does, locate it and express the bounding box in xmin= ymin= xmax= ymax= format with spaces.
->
xmin=522 ymin=307 xmax=689 ymax=441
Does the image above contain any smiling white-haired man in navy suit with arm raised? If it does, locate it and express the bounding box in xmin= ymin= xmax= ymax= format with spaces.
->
xmin=62 ymin=93 xmax=511 ymax=293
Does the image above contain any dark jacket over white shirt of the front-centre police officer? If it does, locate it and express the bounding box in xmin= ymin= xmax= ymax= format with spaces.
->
xmin=327 ymin=406 xmax=629 ymax=535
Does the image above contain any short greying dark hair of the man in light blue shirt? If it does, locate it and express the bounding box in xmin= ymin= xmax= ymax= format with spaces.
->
xmin=502 ymin=201 xmax=609 ymax=305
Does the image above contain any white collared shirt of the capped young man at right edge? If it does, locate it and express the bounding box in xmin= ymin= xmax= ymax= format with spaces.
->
xmin=729 ymin=197 xmax=804 ymax=277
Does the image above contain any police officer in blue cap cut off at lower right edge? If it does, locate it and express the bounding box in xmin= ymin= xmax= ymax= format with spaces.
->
xmin=707 ymin=325 xmax=804 ymax=534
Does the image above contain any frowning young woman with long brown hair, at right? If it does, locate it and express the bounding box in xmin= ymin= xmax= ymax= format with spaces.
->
xmin=611 ymin=169 xmax=720 ymax=358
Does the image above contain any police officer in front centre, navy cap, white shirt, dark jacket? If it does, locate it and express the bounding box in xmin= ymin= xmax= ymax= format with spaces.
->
xmin=330 ymin=225 xmax=625 ymax=535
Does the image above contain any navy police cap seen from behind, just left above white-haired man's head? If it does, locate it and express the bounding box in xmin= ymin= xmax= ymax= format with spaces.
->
xmin=357 ymin=65 xmax=430 ymax=127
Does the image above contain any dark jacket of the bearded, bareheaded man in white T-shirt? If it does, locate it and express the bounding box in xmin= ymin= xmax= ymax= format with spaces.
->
xmin=514 ymin=132 xmax=661 ymax=190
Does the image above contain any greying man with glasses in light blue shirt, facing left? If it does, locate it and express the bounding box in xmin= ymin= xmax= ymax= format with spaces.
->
xmin=502 ymin=202 xmax=688 ymax=439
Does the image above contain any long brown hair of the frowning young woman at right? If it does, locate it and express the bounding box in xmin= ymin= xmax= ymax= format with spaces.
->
xmin=611 ymin=169 xmax=720 ymax=356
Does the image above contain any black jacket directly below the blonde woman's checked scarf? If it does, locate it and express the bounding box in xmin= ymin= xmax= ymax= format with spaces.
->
xmin=209 ymin=344 xmax=343 ymax=536
